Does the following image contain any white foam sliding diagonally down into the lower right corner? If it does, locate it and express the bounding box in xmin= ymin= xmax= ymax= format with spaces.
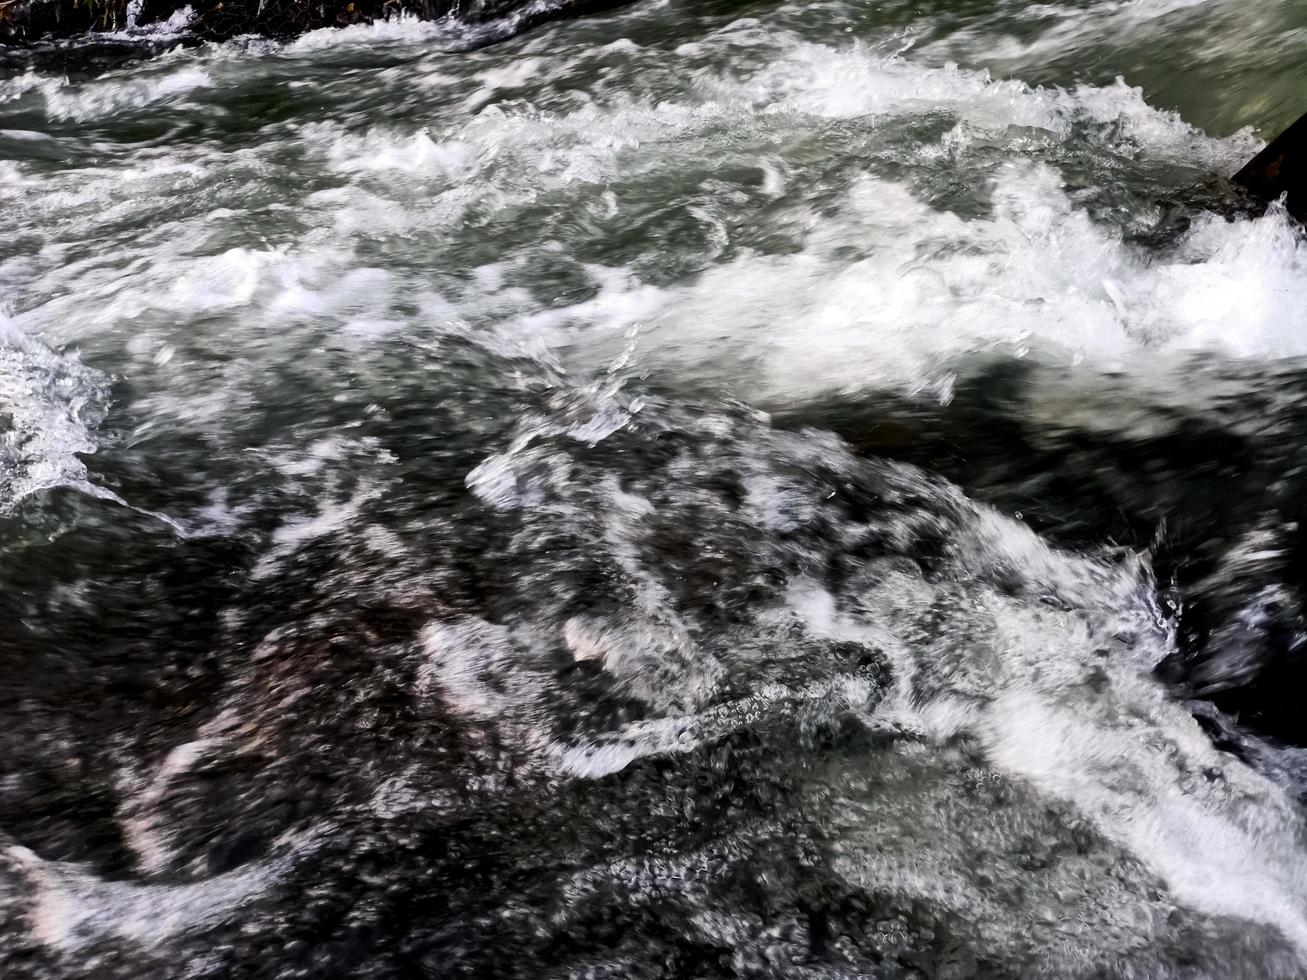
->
xmin=791 ymin=508 xmax=1307 ymax=962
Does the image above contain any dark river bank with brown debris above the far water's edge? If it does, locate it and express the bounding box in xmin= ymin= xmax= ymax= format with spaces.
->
xmin=0 ymin=0 xmax=617 ymax=44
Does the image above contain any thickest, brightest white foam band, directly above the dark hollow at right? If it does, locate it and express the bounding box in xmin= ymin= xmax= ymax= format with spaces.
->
xmin=496 ymin=165 xmax=1307 ymax=396
